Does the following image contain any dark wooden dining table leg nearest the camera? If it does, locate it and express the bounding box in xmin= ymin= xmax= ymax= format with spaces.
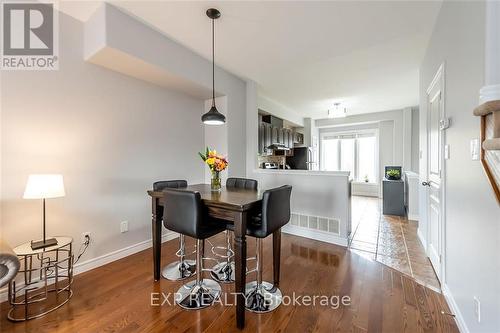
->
xmin=234 ymin=212 xmax=247 ymax=329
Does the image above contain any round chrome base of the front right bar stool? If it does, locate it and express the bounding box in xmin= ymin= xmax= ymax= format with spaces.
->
xmin=245 ymin=281 xmax=283 ymax=313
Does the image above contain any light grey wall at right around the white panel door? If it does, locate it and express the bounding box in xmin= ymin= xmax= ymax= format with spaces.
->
xmin=419 ymin=1 xmax=500 ymax=332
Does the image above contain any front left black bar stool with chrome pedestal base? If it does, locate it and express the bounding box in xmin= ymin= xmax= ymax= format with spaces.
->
xmin=163 ymin=189 xmax=226 ymax=310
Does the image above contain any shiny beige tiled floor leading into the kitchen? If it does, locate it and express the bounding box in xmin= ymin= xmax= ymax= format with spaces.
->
xmin=350 ymin=196 xmax=441 ymax=291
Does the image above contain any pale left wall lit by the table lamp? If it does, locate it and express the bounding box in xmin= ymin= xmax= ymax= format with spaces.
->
xmin=0 ymin=14 xmax=204 ymax=261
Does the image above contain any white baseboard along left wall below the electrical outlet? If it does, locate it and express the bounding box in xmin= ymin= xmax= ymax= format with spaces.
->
xmin=0 ymin=231 xmax=178 ymax=303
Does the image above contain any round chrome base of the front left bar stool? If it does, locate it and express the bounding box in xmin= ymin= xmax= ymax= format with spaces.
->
xmin=175 ymin=279 xmax=221 ymax=310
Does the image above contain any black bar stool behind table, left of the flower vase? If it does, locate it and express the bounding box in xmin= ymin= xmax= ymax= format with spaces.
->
xmin=153 ymin=180 xmax=196 ymax=281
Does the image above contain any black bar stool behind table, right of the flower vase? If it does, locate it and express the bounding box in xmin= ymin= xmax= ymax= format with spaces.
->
xmin=210 ymin=177 xmax=258 ymax=283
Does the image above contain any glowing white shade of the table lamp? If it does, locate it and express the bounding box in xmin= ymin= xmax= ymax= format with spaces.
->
xmin=23 ymin=175 xmax=65 ymax=199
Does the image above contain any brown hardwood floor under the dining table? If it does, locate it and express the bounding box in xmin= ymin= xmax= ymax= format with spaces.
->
xmin=0 ymin=234 xmax=458 ymax=333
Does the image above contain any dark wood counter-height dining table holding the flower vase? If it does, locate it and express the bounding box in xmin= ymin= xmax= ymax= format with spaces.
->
xmin=148 ymin=184 xmax=281 ymax=329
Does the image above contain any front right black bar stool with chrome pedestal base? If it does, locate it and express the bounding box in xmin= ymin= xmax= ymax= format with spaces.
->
xmin=245 ymin=185 xmax=292 ymax=313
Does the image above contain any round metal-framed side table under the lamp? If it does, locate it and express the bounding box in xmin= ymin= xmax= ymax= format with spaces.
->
xmin=7 ymin=236 xmax=73 ymax=321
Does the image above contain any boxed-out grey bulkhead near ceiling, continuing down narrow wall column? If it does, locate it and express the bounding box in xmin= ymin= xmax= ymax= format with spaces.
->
xmin=85 ymin=3 xmax=247 ymax=176
